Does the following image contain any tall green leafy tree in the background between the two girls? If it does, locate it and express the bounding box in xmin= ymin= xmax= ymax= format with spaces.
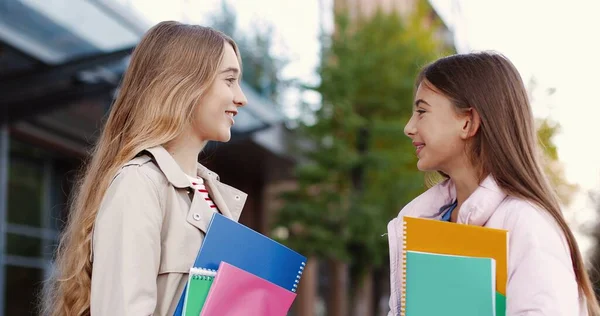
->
xmin=277 ymin=1 xmax=444 ymax=314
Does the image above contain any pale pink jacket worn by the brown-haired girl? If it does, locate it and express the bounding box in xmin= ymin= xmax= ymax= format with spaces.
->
xmin=388 ymin=177 xmax=587 ymax=316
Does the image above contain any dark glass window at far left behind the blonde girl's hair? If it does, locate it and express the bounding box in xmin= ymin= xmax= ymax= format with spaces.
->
xmin=0 ymin=137 xmax=78 ymax=315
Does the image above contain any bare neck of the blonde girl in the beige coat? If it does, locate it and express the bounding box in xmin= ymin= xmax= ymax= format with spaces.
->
xmin=164 ymin=131 xmax=206 ymax=177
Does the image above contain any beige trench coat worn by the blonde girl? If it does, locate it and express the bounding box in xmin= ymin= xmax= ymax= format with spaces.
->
xmin=91 ymin=146 xmax=247 ymax=316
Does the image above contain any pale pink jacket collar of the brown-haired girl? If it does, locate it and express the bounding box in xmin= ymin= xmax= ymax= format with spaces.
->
xmin=400 ymin=175 xmax=507 ymax=226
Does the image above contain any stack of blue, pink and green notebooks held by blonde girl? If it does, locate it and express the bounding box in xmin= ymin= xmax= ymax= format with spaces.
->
xmin=174 ymin=213 xmax=306 ymax=316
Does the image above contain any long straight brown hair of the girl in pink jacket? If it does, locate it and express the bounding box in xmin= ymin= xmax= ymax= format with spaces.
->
xmin=416 ymin=52 xmax=600 ymax=315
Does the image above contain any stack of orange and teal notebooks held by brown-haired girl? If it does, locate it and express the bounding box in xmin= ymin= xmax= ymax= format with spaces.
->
xmin=400 ymin=217 xmax=508 ymax=316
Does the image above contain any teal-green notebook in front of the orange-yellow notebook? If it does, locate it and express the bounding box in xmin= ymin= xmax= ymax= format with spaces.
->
xmin=404 ymin=251 xmax=496 ymax=316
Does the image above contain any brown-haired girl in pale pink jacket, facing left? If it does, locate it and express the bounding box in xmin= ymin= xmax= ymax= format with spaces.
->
xmin=388 ymin=52 xmax=599 ymax=316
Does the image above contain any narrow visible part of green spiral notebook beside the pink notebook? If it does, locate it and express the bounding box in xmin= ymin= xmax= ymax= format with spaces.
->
xmin=183 ymin=268 xmax=217 ymax=316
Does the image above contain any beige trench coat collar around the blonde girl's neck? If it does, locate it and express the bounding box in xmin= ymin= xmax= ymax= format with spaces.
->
xmin=146 ymin=146 xmax=247 ymax=221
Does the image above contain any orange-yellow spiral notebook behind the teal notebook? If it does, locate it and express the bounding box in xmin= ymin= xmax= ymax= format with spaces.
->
xmin=403 ymin=216 xmax=508 ymax=296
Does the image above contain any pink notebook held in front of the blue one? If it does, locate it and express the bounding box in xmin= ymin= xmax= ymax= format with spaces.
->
xmin=200 ymin=262 xmax=296 ymax=316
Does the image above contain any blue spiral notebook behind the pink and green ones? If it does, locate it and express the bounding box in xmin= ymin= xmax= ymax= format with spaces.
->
xmin=175 ymin=213 xmax=306 ymax=316
